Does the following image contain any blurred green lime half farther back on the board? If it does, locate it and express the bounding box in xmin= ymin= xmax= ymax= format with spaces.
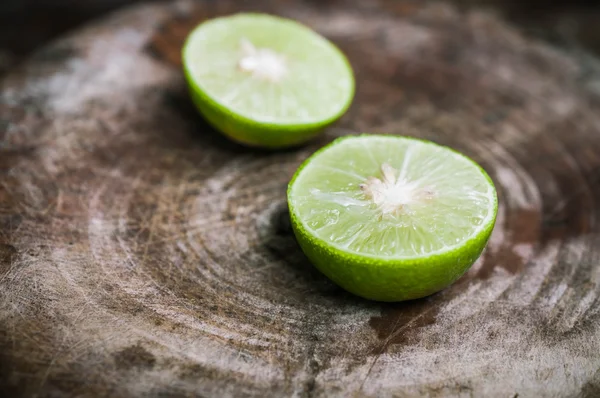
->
xmin=183 ymin=13 xmax=354 ymax=148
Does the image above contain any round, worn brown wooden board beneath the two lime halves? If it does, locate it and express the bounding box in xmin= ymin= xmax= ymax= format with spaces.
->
xmin=0 ymin=0 xmax=600 ymax=397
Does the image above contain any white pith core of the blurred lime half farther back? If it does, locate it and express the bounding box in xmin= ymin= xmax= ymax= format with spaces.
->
xmin=238 ymin=38 xmax=288 ymax=82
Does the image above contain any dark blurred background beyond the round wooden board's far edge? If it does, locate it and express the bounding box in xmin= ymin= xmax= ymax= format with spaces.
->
xmin=0 ymin=0 xmax=600 ymax=73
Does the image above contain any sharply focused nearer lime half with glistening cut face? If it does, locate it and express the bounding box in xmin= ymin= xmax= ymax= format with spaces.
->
xmin=288 ymin=134 xmax=498 ymax=301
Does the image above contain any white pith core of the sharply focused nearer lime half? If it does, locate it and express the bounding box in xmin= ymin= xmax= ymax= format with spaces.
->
xmin=359 ymin=163 xmax=436 ymax=216
